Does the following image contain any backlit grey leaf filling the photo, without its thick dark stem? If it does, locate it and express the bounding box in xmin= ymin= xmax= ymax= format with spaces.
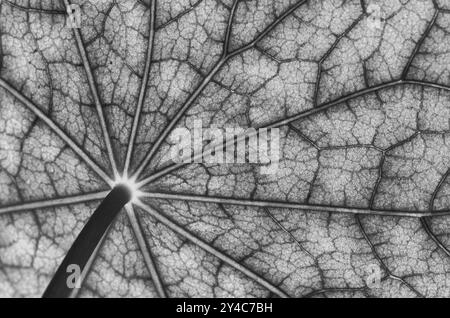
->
xmin=0 ymin=0 xmax=450 ymax=297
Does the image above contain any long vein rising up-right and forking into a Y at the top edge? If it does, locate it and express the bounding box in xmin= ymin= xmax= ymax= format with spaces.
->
xmin=133 ymin=0 xmax=306 ymax=179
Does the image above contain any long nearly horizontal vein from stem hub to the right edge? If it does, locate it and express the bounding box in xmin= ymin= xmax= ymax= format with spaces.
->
xmin=142 ymin=192 xmax=450 ymax=218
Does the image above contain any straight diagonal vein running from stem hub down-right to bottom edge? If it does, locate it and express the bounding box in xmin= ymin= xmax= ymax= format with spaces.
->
xmin=136 ymin=201 xmax=289 ymax=298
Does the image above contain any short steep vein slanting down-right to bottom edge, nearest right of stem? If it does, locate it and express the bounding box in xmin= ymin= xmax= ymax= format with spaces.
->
xmin=125 ymin=204 xmax=167 ymax=298
